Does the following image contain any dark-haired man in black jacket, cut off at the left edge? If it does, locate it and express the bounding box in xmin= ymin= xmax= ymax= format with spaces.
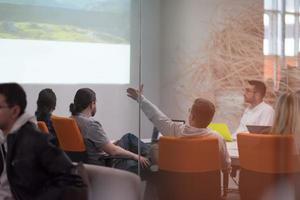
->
xmin=0 ymin=83 xmax=83 ymax=200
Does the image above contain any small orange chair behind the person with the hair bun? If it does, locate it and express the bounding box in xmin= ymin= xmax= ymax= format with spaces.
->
xmin=51 ymin=116 xmax=87 ymax=162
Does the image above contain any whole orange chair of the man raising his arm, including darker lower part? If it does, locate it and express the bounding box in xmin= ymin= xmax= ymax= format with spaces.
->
xmin=157 ymin=136 xmax=221 ymax=200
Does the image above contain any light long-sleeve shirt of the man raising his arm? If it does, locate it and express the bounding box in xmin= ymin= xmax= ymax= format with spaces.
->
xmin=141 ymin=96 xmax=231 ymax=169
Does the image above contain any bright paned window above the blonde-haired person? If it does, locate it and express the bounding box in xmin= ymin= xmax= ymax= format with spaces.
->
xmin=263 ymin=0 xmax=300 ymax=89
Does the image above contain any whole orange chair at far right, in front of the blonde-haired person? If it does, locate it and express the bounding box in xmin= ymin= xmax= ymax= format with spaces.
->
xmin=237 ymin=133 xmax=300 ymax=200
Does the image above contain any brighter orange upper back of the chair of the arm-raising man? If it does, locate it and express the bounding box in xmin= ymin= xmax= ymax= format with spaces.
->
xmin=159 ymin=136 xmax=221 ymax=172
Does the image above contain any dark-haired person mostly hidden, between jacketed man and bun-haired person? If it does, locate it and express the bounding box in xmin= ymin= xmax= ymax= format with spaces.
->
xmin=35 ymin=88 xmax=57 ymax=138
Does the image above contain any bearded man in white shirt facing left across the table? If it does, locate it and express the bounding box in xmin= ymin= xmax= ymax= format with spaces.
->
xmin=233 ymin=80 xmax=274 ymax=138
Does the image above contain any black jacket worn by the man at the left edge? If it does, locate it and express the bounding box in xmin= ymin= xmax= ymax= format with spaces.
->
xmin=6 ymin=122 xmax=73 ymax=200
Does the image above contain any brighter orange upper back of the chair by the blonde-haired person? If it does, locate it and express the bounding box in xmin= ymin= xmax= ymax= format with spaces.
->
xmin=237 ymin=133 xmax=300 ymax=174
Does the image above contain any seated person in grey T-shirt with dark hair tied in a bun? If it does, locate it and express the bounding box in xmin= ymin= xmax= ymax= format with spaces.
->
xmin=70 ymin=88 xmax=150 ymax=173
